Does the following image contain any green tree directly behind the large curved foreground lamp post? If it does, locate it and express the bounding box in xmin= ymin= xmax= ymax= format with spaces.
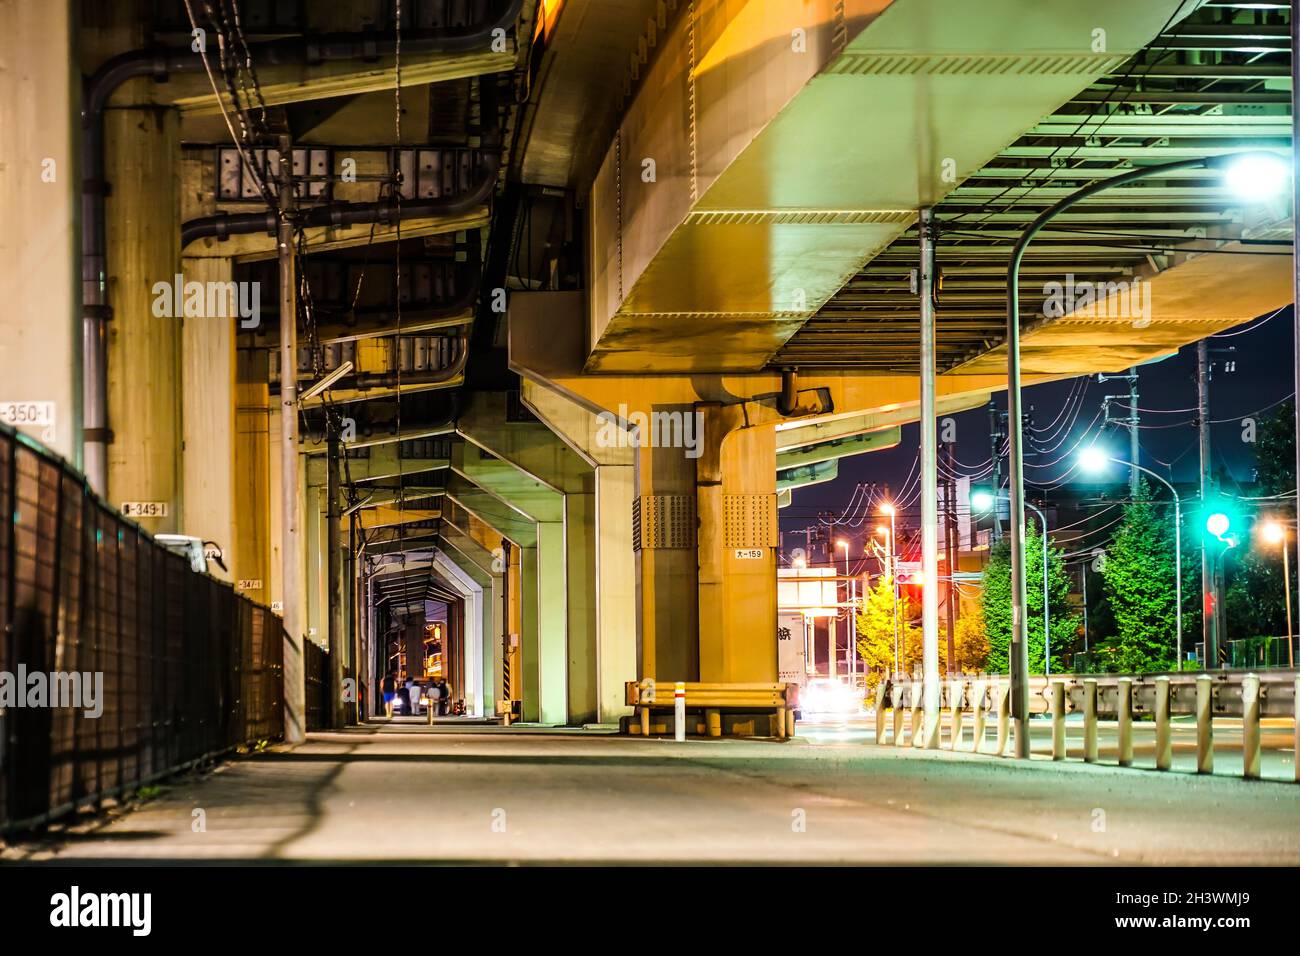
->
xmin=980 ymin=522 xmax=1079 ymax=674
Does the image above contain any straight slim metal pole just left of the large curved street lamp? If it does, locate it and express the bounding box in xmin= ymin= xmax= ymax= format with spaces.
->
xmin=917 ymin=208 xmax=940 ymax=749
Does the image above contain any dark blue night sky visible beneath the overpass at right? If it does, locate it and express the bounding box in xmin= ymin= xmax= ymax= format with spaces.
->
xmin=781 ymin=306 xmax=1295 ymax=561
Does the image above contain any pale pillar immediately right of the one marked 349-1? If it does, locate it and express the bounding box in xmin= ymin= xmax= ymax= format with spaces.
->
xmin=181 ymin=258 xmax=236 ymax=580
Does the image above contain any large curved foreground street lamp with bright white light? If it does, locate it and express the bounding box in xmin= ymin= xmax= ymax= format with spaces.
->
xmin=1006 ymin=152 xmax=1279 ymax=757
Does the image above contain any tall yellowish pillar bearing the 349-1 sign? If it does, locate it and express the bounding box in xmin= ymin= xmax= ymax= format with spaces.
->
xmin=104 ymin=105 xmax=180 ymax=532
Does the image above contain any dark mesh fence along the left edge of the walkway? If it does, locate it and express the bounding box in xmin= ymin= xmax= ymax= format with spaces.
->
xmin=0 ymin=427 xmax=283 ymax=831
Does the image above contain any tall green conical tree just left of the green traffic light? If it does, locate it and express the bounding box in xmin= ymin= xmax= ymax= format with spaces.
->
xmin=1101 ymin=479 xmax=1177 ymax=672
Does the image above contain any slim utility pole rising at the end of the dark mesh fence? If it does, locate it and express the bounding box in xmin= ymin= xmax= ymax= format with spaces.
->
xmin=276 ymin=135 xmax=307 ymax=744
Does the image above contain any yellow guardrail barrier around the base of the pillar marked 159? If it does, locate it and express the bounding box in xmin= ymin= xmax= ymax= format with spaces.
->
xmin=621 ymin=678 xmax=798 ymax=740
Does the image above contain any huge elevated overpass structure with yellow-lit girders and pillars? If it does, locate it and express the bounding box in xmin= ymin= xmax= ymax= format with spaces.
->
xmin=0 ymin=0 xmax=1294 ymax=837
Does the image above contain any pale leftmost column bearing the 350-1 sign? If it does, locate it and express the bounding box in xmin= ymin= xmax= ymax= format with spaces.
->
xmin=0 ymin=0 xmax=82 ymax=467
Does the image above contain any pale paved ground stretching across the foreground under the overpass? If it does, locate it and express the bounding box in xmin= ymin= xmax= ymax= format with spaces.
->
xmin=0 ymin=724 xmax=1300 ymax=865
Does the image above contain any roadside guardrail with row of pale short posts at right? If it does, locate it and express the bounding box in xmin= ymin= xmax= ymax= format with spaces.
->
xmin=875 ymin=670 xmax=1300 ymax=782
